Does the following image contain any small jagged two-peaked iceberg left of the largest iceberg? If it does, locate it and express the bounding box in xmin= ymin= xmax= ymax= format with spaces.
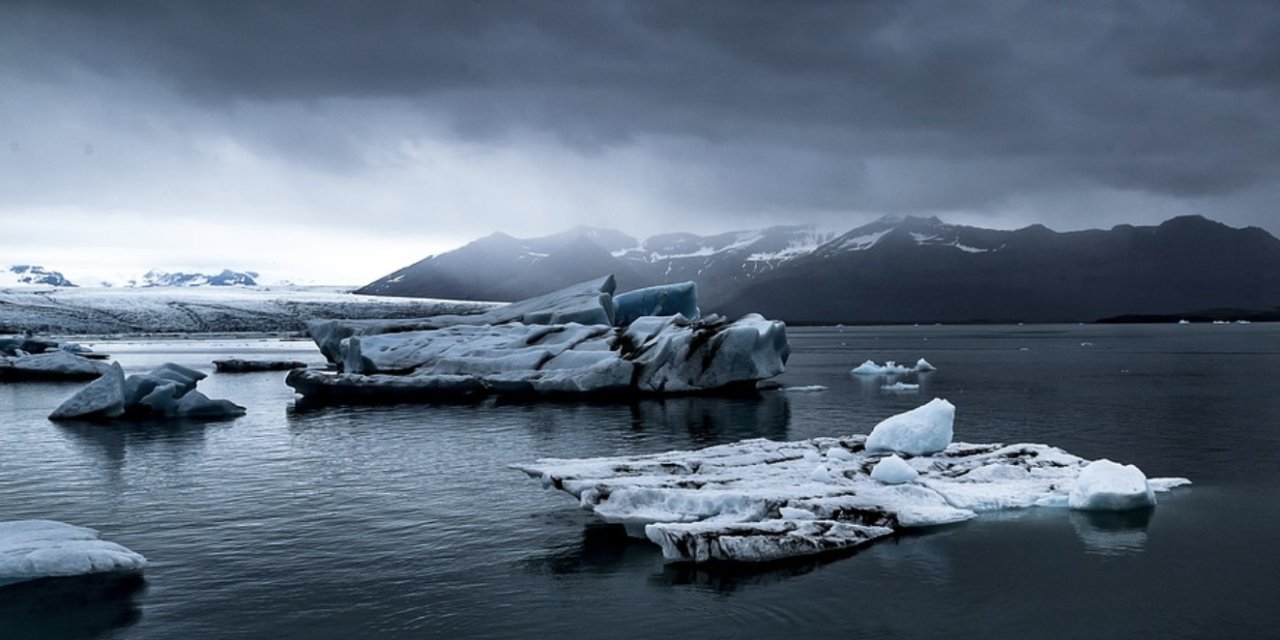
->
xmin=49 ymin=362 xmax=244 ymax=420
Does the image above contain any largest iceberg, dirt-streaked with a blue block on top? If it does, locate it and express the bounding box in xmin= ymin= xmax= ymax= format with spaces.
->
xmin=285 ymin=276 xmax=790 ymax=402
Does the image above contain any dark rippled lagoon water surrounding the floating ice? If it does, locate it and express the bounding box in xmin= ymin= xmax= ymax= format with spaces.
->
xmin=0 ymin=324 xmax=1280 ymax=640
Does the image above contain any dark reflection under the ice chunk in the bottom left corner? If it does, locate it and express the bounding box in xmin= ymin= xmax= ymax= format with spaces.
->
xmin=0 ymin=573 xmax=146 ymax=640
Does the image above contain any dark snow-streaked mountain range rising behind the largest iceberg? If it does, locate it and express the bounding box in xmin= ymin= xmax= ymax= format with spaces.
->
xmin=357 ymin=216 xmax=1280 ymax=323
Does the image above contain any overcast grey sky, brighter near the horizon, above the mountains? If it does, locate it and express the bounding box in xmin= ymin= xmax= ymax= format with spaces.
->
xmin=0 ymin=0 xmax=1280 ymax=284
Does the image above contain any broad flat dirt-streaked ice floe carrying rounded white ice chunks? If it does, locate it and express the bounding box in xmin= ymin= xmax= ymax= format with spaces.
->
xmin=515 ymin=401 xmax=1189 ymax=562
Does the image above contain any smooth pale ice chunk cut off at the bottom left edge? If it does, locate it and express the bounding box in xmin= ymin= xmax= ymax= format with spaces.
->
xmin=0 ymin=520 xmax=147 ymax=586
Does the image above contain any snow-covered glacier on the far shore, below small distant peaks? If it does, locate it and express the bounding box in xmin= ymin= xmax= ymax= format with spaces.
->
xmin=0 ymin=287 xmax=493 ymax=334
